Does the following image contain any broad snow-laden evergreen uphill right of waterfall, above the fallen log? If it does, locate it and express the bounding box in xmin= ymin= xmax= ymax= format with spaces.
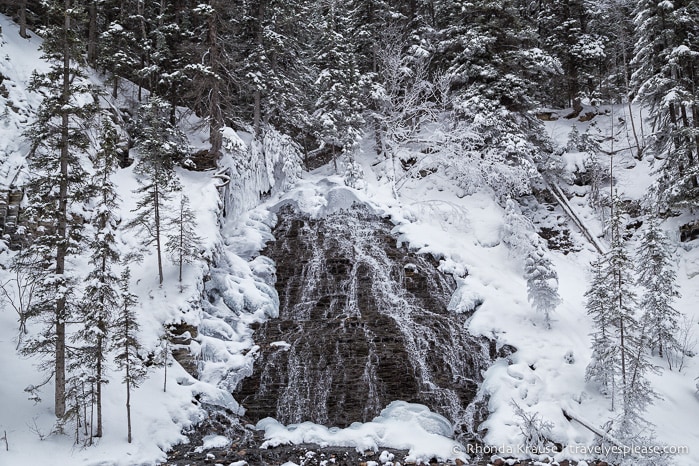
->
xmin=432 ymin=0 xmax=559 ymax=203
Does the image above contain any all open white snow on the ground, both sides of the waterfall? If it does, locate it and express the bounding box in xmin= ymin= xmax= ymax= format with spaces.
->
xmin=0 ymin=10 xmax=699 ymax=466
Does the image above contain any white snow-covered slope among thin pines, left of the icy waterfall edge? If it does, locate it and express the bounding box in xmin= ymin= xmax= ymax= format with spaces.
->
xmin=0 ymin=15 xmax=220 ymax=465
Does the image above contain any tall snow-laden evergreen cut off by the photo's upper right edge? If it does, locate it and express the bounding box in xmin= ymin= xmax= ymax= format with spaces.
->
xmin=632 ymin=0 xmax=699 ymax=208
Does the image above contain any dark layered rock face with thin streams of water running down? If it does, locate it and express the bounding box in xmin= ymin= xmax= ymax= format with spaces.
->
xmin=234 ymin=208 xmax=492 ymax=434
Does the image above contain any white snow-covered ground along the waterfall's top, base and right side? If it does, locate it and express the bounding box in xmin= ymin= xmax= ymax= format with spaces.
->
xmin=234 ymin=108 xmax=699 ymax=466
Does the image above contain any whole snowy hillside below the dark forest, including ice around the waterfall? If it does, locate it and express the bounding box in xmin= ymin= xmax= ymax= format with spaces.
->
xmin=0 ymin=5 xmax=699 ymax=466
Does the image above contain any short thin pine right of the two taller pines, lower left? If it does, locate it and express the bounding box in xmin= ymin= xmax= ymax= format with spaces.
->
xmin=113 ymin=267 xmax=146 ymax=443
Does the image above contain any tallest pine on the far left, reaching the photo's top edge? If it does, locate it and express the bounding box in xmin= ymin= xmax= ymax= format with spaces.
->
xmin=24 ymin=0 xmax=96 ymax=418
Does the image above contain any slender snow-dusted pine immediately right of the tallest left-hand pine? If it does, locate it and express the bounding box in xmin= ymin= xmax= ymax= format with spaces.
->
xmin=76 ymin=122 xmax=120 ymax=437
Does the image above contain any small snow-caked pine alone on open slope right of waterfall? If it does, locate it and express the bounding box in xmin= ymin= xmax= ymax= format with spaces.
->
xmin=524 ymin=235 xmax=561 ymax=329
